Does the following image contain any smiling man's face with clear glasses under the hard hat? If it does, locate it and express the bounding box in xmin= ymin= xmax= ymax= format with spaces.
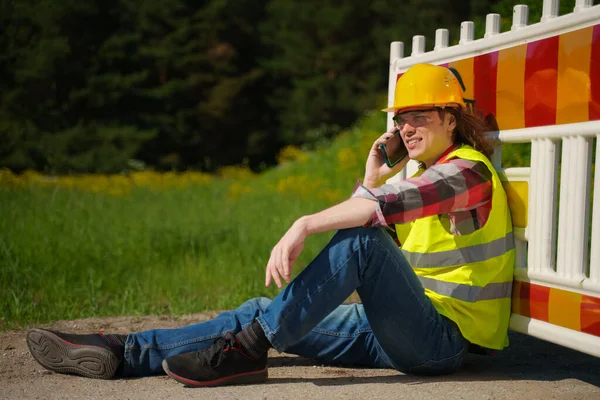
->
xmin=394 ymin=109 xmax=456 ymax=167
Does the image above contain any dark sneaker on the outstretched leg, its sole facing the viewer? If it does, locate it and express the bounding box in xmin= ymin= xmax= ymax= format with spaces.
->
xmin=27 ymin=329 xmax=125 ymax=379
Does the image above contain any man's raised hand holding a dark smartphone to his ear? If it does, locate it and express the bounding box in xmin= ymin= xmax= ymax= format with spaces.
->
xmin=363 ymin=128 xmax=409 ymax=188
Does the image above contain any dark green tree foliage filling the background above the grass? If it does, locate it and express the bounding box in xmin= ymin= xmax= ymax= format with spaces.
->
xmin=0 ymin=0 xmax=574 ymax=173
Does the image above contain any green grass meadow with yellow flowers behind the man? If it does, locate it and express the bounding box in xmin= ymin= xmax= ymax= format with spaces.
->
xmin=0 ymin=113 xmax=536 ymax=329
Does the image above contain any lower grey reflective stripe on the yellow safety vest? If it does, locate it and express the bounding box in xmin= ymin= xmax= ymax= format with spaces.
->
xmin=419 ymin=276 xmax=512 ymax=303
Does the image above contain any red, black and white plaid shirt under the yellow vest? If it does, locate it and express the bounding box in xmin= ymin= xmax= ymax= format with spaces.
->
xmin=352 ymin=146 xmax=492 ymax=236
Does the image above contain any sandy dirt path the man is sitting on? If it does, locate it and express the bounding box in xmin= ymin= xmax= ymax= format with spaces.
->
xmin=0 ymin=313 xmax=600 ymax=400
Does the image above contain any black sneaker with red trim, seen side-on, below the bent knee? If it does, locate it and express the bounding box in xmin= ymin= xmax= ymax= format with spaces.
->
xmin=162 ymin=333 xmax=268 ymax=387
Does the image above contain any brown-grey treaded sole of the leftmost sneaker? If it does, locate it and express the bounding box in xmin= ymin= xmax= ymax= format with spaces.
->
xmin=27 ymin=329 xmax=120 ymax=379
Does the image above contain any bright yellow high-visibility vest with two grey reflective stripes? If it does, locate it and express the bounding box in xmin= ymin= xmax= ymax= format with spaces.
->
xmin=396 ymin=145 xmax=515 ymax=350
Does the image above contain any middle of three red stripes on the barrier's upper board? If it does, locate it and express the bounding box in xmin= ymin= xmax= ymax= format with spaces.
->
xmin=525 ymin=36 xmax=559 ymax=127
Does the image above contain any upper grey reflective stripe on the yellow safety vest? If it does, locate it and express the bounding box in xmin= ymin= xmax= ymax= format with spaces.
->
xmin=402 ymin=232 xmax=514 ymax=268
